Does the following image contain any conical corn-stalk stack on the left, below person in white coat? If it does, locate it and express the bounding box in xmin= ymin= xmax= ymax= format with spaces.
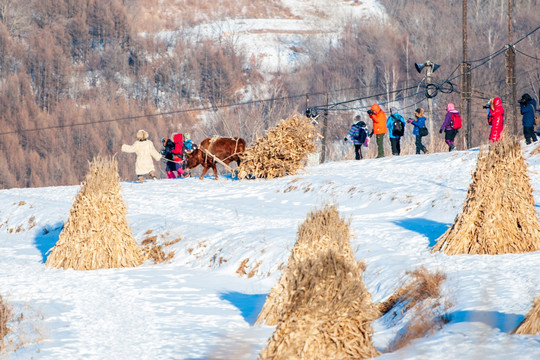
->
xmin=46 ymin=157 xmax=144 ymax=270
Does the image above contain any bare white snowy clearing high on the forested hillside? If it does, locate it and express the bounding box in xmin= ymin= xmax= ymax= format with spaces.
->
xmin=159 ymin=0 xmax=386 ymax=74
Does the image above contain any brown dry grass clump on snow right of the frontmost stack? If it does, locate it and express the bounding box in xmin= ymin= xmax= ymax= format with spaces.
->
xmin=378 ymin=266 xmax=451 ymax=351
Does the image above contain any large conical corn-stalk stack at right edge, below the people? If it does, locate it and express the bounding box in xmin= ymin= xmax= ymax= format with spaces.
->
xmin=433 ymin=139 xmax=540 ymax=255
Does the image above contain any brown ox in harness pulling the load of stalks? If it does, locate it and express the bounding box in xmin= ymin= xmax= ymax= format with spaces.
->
xmin=186 ymin=137 xmax=246 ymax=180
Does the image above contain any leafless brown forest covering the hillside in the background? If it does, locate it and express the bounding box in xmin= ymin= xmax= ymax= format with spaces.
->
xmin=0 ymin=0 xmax=540 ymax=188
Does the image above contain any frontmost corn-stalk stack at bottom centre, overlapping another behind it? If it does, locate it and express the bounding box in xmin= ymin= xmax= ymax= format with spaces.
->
xmin=259 ymin=250 xmax=380 ymax=360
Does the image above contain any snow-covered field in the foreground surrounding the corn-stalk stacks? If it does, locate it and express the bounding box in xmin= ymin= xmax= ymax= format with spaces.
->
xmin=0 ymin=146 xmax=540 ymax=360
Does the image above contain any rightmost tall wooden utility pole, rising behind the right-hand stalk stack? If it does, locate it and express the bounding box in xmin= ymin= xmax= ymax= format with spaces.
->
xmin=506 ymin=0 xmax=519 ymax=136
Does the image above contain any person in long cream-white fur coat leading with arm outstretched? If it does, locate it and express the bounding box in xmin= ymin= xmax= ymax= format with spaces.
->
xmin=122 ymin=130 xmax=162 ymax=183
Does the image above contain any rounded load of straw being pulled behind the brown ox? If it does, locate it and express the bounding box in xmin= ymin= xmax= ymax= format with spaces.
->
xmin=238 ymin=113 xmax=318 ymax=179
